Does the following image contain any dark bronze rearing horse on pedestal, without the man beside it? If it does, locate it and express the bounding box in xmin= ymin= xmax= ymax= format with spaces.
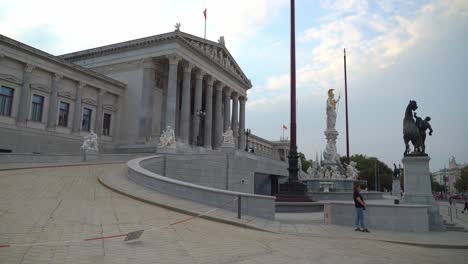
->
xmin=403 ymin=100 xmax=423 ymax=156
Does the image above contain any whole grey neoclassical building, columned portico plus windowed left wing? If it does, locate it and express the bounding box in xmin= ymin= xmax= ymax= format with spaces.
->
xmin=0 ymin=28 xmax=287 ymax=157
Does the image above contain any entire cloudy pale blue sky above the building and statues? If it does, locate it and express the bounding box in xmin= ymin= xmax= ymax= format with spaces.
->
xmin=0 ymin=0 xmax=468 ymax=171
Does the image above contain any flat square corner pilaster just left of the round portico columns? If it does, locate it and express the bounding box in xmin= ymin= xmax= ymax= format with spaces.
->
xmin=138 ymin=58 xmax=156 ymax=140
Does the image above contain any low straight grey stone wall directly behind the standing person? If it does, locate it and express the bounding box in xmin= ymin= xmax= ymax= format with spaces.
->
xmin=324 ymin=202 xmax=429 ymax=232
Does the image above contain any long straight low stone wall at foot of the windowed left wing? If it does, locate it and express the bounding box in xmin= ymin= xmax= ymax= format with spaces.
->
xmin=0 ymin=153 xmax=141 ymax=164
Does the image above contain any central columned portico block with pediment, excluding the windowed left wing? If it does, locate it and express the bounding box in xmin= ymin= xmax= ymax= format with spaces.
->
xmin=60 ymin=30 xmax=252 ymax=149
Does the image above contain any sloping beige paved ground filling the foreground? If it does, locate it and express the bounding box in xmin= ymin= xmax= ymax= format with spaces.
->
xmin=0 ymin=163 xmax=468 ymax=263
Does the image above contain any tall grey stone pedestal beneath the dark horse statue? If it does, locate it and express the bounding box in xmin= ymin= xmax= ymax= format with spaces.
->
xmin=402 ymin=156 xmax=445 ymax=231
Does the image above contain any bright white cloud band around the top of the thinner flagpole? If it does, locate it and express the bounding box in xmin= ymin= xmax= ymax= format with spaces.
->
xmin=258 ymin=0 xmax=468 ymax=102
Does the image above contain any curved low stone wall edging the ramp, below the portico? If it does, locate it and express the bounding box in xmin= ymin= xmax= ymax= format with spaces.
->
xmin=127 ymin=155 xmax=275 ymax=219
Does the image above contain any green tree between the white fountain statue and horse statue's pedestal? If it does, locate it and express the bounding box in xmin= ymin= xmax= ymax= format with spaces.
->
xmin=341 ymin=154 xmax=393 ymax=191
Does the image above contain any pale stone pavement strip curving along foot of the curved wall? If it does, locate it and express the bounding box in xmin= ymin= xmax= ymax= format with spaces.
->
xmin=99 ymin=170 xmax=468 ymax=249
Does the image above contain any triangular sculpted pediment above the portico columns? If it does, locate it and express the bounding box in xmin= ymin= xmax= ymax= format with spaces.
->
xmin=181 ymin=33 xmax=252 ymax=88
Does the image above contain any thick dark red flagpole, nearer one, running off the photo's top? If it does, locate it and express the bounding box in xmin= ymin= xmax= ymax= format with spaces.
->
xmin=288 ymin=0 xmax=299 ymax=183
